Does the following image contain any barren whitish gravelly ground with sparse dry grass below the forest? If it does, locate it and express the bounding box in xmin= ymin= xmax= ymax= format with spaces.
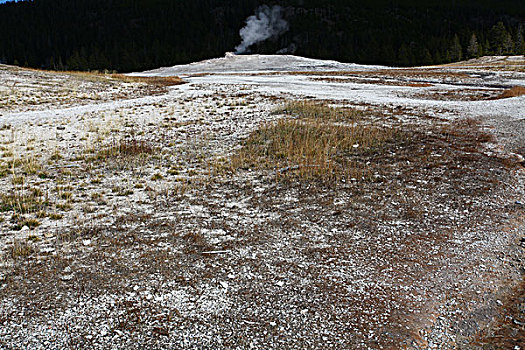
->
xmin=0 ymin=55 xmax=525 ymax=349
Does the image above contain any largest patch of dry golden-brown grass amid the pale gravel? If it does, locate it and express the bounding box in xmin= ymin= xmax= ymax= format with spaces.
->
xmin=231 ymin=102 xmax=397 ymax=180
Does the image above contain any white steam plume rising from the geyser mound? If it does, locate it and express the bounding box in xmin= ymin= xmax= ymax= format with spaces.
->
xmin=235 ymin=5 xmax=289 ymax=54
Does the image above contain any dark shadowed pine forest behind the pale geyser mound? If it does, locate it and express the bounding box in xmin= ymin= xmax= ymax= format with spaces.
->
xmin=0 ymin=0 xmax=525 ymax=72
